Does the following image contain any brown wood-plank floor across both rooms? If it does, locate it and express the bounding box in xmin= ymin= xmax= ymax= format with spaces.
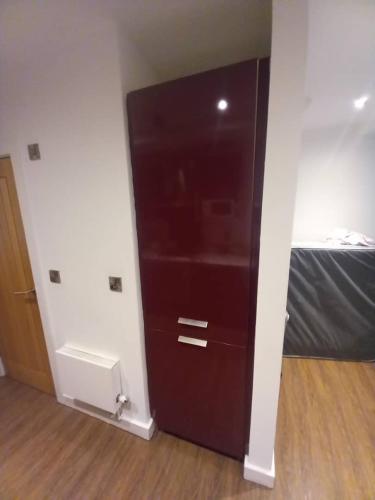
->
xmin=0 ymin=359 xmax=375 ymax=500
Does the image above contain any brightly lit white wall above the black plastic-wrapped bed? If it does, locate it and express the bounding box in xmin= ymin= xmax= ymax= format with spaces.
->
xmin=293 ymin=119 xmax=375 ymax=241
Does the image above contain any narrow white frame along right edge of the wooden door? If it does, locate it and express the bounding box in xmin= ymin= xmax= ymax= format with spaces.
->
xmin=0 ymin=154 xmax=62 ymax=401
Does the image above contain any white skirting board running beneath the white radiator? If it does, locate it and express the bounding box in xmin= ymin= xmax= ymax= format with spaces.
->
xmin=58 ymin=396 xmax=155 ymax=441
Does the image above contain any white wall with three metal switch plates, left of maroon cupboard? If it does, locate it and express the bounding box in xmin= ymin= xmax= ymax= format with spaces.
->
xmin=0 ymin=1 xmax=159 ymax=423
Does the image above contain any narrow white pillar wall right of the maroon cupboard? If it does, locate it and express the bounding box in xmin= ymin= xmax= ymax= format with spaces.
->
xmin=244 ymin=0 xmax=307 ymax=486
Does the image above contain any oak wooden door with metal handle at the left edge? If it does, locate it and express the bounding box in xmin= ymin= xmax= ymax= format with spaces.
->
xmin=0 ymin=158 xmax=54 ymax=394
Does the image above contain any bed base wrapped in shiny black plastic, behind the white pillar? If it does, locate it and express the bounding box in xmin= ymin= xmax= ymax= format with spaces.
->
xmin=284 ymin=243 xmax=375 ymax=361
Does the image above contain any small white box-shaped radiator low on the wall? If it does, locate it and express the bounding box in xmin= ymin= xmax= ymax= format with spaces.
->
xmin=56 ymin=345 xmax=121 ymax=413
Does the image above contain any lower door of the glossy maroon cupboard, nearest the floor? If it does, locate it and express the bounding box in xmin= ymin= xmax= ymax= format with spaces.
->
xmin=147 ymin=331 xmax=250 ymax=459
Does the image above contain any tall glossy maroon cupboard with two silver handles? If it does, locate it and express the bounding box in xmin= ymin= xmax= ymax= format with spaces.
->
xmin=127 ymin=59 xmax=268 ymax=458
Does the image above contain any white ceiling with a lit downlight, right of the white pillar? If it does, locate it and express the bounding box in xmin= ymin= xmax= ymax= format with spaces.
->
xmin=305 ymin=0 xmax=375 ymax=133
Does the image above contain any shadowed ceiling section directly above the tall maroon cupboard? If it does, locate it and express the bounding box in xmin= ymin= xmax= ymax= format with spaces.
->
xmin=106 ymin=0 xmax=271 ymax=79
